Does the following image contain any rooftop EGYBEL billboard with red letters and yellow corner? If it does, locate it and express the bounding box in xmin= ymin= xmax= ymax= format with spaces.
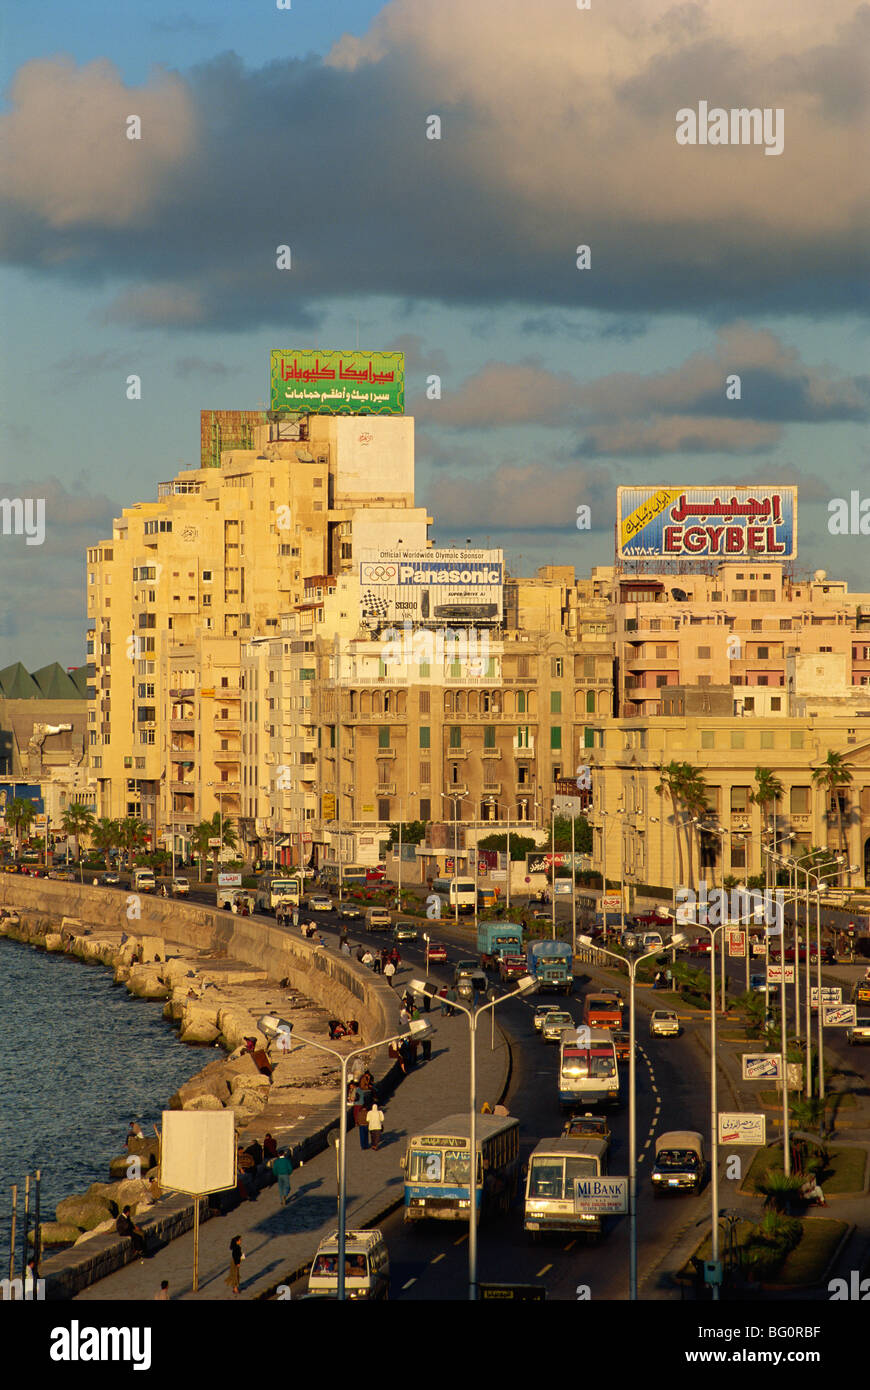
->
xmin=616 ymin=484 xmax=798 ymax=560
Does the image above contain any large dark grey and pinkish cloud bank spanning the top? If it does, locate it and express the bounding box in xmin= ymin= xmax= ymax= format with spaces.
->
xmin=0 ymin=0 xmax=870 ymax=329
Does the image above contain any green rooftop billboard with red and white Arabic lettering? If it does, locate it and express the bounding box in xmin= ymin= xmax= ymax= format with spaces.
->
xmin=271 ymin=348 xmax=404 ymax=416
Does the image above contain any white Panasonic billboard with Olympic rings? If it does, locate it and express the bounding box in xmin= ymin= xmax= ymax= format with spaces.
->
xmin=360 ymin=549 xmax=504 ymax=625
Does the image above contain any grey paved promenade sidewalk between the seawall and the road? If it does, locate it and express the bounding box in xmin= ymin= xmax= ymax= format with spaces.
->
xmin=75 ymin=1009 xmax=510 ymax=1302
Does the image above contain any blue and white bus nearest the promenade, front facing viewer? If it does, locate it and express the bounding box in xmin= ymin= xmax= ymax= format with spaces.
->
xmin=402 ymin=1113 xmax=520 ymax=1220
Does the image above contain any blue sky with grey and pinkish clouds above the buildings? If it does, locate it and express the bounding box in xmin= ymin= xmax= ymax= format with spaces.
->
xmin=0 ymin=0 xmax=870 ymax=669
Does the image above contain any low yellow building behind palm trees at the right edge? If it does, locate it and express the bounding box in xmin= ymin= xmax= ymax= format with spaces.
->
xmin=585 ymin=711 xmax=870 ymax=885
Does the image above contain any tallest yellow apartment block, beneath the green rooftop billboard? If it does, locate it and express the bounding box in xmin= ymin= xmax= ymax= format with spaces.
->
xmin=88 ymin=413 xmax=429 ymax=849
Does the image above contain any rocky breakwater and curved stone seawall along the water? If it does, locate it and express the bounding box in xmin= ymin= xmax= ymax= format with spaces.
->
xmin=0 ymin=880 xmax=399 ymax=1298
